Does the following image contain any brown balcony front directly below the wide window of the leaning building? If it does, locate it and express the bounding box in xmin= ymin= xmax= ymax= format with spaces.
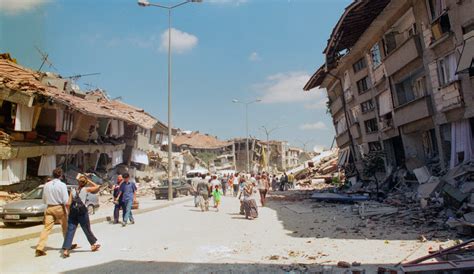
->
xmin=393 ymin=96 xmax=431 ymax=127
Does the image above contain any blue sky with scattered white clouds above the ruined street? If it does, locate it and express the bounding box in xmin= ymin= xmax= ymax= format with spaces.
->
xmin=0 ymin=0 xmax=351 ymax=150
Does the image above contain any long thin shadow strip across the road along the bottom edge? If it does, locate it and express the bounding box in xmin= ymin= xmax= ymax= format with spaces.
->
xmin=65 ymin=260 xmax=394 ymax=273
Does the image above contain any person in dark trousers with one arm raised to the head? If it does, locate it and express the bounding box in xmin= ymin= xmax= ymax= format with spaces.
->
xmin=63 ymin=175 xmax=100 ymax=258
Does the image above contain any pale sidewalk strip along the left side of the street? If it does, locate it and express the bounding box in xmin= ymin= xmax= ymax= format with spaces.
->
xmin=0 ymin=196 xmax=192 ymax=246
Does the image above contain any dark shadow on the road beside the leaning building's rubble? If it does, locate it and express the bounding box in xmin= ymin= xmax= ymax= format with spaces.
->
xmin=266 ymin=191 xmax=452 ymax=241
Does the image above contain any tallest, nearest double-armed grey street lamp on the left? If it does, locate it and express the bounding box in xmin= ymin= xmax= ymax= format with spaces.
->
xmin=138 ymin=0 xmax=202 ymax=201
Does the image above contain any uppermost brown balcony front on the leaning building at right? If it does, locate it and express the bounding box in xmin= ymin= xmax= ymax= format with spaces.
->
xmin=384 ymin=35 xmax=421 ymax=76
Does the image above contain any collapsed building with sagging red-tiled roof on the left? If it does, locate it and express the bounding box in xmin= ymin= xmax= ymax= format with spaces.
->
xmin=0 ymin=55 xmax=167 ymax=190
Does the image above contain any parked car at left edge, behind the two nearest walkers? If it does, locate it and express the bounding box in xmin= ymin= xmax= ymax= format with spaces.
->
xmin=0 ymin=185 xmax=99 ymax=227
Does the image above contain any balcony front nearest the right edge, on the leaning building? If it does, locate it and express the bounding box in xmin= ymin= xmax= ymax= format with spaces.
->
xmin=433 ymin=81 xmax=463 ymax=112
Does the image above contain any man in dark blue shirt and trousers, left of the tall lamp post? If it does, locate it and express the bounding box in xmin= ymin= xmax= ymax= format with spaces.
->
xmin=115 ymin=173 xmax=137 ymax=226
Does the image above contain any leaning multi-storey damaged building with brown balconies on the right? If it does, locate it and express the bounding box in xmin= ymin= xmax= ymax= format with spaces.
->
xmin=304 ymin=0 xmax=474 ymax=176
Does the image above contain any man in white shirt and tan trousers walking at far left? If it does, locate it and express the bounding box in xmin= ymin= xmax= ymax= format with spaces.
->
xmin=35 ymin=168 xmax=70 ymax=257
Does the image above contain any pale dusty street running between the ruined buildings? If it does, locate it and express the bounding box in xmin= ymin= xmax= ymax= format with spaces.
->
xmin=0 ymin=195 xmax=456 ymax=273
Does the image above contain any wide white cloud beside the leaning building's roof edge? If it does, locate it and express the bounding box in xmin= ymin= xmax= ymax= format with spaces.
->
xmin=253 ymin=71 xmax=326 ymax=105
